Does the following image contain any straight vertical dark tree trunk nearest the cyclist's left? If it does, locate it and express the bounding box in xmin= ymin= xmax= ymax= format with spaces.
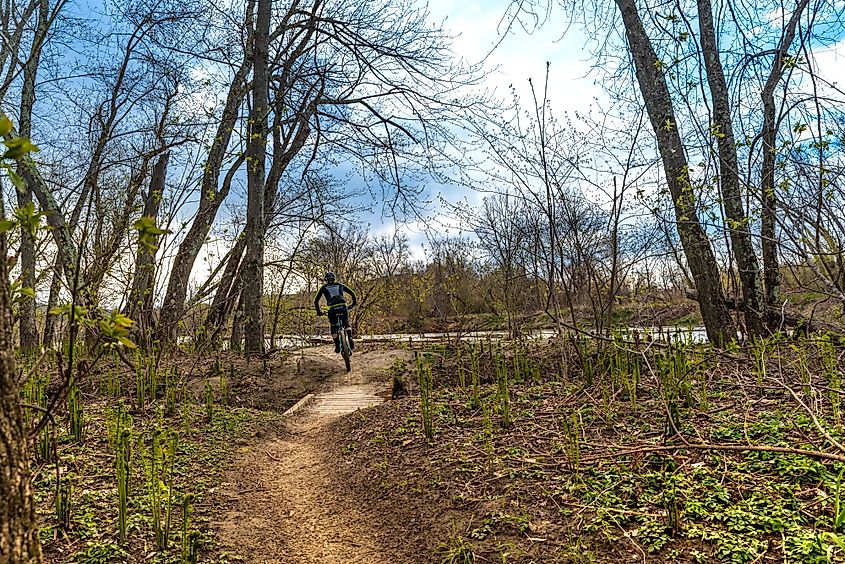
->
xmin=241 ymin=0 xmax=272 ymax=354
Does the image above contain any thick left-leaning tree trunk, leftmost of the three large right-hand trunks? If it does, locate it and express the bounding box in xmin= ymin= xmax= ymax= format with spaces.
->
xmin=616 ymin=0 xmax=736 ymax=346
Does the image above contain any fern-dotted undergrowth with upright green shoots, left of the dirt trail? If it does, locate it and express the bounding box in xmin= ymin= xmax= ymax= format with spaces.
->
xmin=22 ymin=350 xmax=279 ymax=564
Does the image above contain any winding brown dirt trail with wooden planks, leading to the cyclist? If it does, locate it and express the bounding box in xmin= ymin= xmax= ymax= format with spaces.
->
xmin=218 ymin=347 xmax=412 ymax=564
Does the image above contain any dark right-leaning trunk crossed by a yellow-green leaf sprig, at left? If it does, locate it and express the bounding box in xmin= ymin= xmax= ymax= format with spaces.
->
xmin=126 ymin=151 xmax=170 ymax=335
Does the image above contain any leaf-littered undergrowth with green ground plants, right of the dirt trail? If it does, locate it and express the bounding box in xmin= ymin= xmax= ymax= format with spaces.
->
xmin=332 ymin=339 xmax=845 ymax=564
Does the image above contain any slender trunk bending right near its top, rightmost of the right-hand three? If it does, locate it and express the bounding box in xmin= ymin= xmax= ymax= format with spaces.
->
xmin=760 ymin=0 xmax=809 ymax=330
